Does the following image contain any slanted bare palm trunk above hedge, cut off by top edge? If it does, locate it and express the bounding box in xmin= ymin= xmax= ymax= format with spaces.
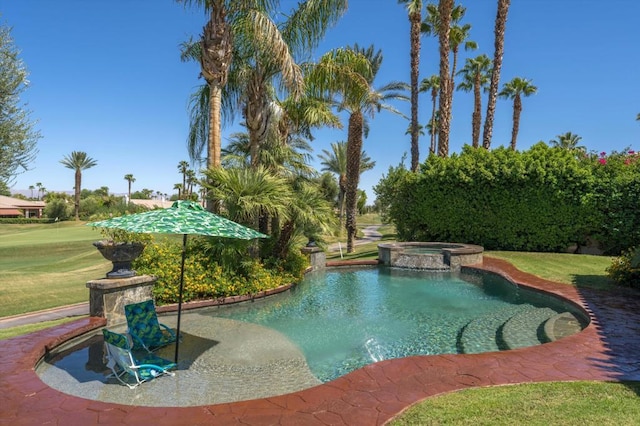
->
xmin=482 ymin=0 xmax=511 ymax=149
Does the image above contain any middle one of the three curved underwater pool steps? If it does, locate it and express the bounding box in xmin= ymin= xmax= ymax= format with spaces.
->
xmin=498 ymin=308 xmax=557 ymax=349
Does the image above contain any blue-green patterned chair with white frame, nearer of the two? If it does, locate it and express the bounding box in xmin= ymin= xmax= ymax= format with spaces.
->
xmin=102 ymin=328 xmax=176 ymax=389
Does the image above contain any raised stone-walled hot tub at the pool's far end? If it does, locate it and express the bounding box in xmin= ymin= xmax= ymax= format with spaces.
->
xmin=378 ymin=242 xmax=484 ymax=271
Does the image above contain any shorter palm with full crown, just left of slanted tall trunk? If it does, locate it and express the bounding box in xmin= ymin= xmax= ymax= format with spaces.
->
xmin=458 ymin=54 xmax=491 ymax=148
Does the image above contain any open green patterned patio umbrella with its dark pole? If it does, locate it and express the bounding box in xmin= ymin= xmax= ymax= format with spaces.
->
xmin=87 ymin=200 xmax=268 ymax=363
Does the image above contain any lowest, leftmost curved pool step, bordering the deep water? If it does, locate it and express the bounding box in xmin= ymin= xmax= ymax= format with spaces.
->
xmin=458 ymin=305 xmax=536 ymax=354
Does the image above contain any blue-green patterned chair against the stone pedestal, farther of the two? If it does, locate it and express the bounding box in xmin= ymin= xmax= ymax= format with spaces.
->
xmin=124 ymin=299 xmax=176 ymax=352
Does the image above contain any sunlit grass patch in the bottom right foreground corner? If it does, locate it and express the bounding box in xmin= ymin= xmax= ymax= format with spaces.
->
xmin=390 ymin=382 xmax=640 ymax=426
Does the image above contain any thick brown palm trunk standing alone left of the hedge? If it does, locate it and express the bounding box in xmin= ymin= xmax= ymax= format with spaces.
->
xmin=346 ymin=111 xmax=364 ymax=253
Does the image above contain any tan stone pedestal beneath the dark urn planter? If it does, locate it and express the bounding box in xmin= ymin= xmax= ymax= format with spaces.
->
xmin=87 ymin=275 xmax=158 ymax=326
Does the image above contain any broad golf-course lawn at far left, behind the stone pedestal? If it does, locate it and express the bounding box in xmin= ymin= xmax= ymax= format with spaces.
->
xmin=0 ymin=222 xmax=111 ymax=317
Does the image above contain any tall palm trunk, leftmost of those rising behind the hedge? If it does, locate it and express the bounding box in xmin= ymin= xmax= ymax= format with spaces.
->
xmin=398 ymin=0 xmax=422 ymax=172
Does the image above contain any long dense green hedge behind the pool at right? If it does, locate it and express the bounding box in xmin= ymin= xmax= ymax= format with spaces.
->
xmin=374 ymin=142 xmax=640 ymax=252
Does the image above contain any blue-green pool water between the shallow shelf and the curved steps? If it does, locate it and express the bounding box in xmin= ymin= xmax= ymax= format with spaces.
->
xmin=205 ymin=268 xmax=530 ymax=382
